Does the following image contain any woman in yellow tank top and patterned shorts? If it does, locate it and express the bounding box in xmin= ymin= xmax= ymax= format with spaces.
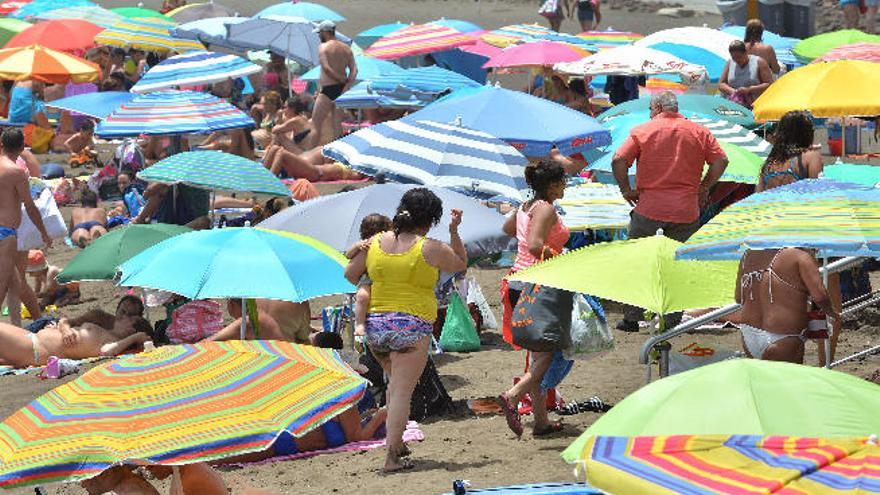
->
xmin=345 ymin=188 xmax=467 ymax=472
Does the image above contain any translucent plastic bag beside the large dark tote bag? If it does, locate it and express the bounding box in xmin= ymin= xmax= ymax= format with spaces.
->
xmin=563 ymin=294 xmax=614 ymax=359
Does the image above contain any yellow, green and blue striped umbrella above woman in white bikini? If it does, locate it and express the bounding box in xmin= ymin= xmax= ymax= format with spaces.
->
xmin=678 ymin=179 xmax=880 ymax=260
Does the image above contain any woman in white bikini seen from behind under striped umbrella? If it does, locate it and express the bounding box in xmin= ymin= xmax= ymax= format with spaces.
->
xmin=736 ymin=248 xmax=838 ymax=363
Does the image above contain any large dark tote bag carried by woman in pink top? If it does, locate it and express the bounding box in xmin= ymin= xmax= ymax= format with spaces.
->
xmin=510 ymin=283 xmax=574 ymax=352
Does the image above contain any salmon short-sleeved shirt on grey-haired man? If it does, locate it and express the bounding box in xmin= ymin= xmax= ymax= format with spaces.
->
xmin=615 ymin=112 xmax=726 ymax=223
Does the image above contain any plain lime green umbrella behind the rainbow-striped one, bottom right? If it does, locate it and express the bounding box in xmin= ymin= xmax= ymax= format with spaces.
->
xmin=562 ymin=359 xmax=880 ymax=462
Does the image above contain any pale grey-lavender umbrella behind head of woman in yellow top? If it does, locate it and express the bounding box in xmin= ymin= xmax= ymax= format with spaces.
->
xmin=260 ymin=184 xmax=511 ymax=258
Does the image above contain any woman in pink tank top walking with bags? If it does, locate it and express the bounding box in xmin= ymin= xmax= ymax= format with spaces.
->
xmin=498 ymin=160 xmax=569 ymax=436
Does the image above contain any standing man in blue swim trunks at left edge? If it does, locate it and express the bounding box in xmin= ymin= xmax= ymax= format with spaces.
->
xmin=0 ymin=128 xmax=52 ymax=324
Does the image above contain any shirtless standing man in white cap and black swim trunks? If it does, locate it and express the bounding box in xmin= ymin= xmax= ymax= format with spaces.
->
xmin=312 ymin=21 xmax=357 ymax=146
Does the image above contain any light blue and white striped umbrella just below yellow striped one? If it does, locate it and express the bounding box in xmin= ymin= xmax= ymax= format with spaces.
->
xmin=131 ymin=51 xmax=262 ymax=93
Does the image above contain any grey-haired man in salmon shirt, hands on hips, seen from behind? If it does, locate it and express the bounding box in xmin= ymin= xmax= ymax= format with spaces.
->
xmin=611 ymin=91 xmax=727 ymax=332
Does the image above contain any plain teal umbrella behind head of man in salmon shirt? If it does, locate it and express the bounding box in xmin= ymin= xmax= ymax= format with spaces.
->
xmin=598 ymin=94 xmax=757 ymax=129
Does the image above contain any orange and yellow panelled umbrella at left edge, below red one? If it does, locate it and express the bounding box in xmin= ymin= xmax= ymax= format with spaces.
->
xmin=0 ymin=44 xmax=101 ymax=84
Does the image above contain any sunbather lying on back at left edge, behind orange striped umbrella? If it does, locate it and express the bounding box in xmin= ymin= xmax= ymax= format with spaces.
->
xmin=0 ymin=316 xmax=151 ymax=368
